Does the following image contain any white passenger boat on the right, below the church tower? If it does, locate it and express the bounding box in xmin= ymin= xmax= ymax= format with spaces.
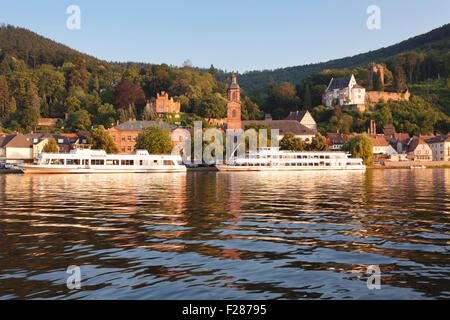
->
xmin=216 ymin=147 xmax=366 ymax=171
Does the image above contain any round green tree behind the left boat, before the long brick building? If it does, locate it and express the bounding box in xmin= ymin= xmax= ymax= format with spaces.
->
xmin=136 ymin=125 xmax=173 ymax=154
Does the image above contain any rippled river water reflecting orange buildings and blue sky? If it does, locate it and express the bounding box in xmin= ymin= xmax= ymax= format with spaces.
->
xmin=0 ymin=169 xmax=450 ymax=299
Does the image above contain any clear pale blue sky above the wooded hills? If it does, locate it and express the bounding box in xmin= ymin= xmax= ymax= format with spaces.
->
xmin=0 ymin=0 xmax=450 ymax=72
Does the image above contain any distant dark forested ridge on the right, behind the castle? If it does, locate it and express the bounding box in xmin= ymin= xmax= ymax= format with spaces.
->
xmin=216 ymin=24 xmax=450 ymax=92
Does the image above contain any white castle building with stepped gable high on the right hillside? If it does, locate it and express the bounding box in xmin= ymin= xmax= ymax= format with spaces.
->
xmin=322 ymin=74 xmax=366 ymax=107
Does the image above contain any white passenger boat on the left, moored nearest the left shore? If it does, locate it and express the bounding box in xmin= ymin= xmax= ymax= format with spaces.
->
xmin=19 ymin=150 xmax=186 ymax=173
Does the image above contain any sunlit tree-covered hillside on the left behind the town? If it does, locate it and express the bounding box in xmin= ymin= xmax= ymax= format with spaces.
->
xmin=0 ymin=25 xmax=263 ymax=131
